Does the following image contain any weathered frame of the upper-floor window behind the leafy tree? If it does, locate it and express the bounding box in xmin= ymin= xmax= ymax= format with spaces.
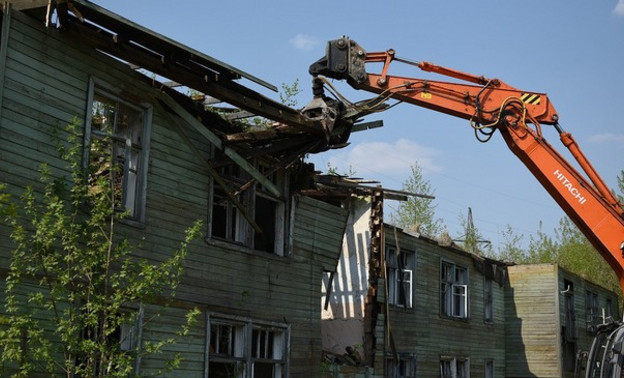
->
xmin=83 ymin=77 xmax=152 ymax=226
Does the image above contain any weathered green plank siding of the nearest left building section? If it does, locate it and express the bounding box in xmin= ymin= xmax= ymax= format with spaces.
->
xmin=0 ymin=7 xmax=347 ymax=377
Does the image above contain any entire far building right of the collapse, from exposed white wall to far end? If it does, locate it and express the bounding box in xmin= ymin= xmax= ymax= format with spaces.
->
xmin=322 ymin=196 xmax=619 ymax=378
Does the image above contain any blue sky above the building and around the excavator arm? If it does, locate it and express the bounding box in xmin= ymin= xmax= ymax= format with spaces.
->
xmin=95 ymin=0 xmax=624 ymax=252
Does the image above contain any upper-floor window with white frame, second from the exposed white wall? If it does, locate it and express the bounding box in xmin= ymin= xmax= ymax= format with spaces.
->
xmin=440 ymin=261 xmax=468 ymax=318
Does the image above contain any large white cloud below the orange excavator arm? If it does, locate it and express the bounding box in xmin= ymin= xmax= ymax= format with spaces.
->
xmin=329 ymin=139 xmax=442 ymax=179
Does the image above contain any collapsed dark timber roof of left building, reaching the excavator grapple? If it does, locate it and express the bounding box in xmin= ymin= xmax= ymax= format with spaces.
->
xmin=10 ymin=0 xmax=350 ymax=177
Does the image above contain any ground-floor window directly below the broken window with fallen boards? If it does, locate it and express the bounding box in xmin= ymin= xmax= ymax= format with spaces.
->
xmin=208 ymin=317 xmax=288 ymax=378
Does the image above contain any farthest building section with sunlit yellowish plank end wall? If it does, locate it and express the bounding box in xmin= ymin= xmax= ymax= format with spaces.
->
xmin=505 ymin=264 xmax=620 ymax=377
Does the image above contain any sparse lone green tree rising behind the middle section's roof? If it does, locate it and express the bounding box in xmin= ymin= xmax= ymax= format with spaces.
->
xmin=391 ymin=162 xmax=444 ymax=238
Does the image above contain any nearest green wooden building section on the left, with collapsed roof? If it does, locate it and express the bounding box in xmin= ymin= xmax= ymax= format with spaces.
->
xmin=0 ymin=0 xmax=347 ymax=378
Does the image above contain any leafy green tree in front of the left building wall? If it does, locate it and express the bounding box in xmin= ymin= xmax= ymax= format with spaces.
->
xmin=0 ymin=120 xmax=201 ymax=377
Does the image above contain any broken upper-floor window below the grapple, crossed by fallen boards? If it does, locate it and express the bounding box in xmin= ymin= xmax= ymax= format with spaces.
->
xmin=208 ymin=161 xmax=292 ymax=256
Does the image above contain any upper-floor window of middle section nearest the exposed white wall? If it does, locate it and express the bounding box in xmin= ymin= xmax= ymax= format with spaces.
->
xmin=386 ymin=247 xmax=415 ymax=308
